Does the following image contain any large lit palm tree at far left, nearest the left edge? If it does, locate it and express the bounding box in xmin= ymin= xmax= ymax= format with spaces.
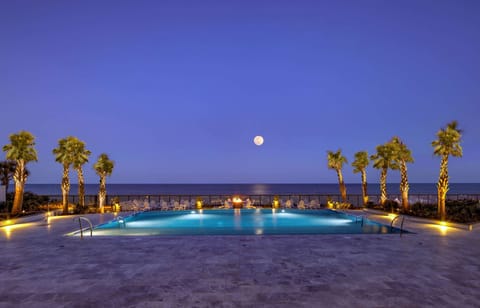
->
xmin=3 ymin=131 xmax=38 ymax=215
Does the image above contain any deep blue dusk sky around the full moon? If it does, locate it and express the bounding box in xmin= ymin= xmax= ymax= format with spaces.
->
xmin=0 ymin=0 xmax=480 ymax=183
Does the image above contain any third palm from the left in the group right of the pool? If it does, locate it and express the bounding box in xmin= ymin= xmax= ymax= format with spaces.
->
xmin=370 ymin=142 xmax=398 ymax=205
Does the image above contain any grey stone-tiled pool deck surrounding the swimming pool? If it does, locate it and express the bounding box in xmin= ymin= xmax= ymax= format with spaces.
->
xmin=0 ymin=212 xmax=480 ymax=307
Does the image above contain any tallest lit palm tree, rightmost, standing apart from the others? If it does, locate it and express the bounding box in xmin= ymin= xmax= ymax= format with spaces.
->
xmin=432 ymin=121 xmax=463 ymax=220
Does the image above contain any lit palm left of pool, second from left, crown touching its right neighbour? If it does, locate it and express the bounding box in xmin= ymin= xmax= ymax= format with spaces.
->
xmin=53 ymin=136 xmax=76 ymax=215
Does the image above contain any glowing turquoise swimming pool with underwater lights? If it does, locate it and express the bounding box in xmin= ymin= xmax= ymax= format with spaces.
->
xmin=89 ymin=209 xmax=400 ymax=236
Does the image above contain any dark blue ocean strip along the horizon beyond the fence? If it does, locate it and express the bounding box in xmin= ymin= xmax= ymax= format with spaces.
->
xmin=9 ymin=183 xmax=480 ymax=196
